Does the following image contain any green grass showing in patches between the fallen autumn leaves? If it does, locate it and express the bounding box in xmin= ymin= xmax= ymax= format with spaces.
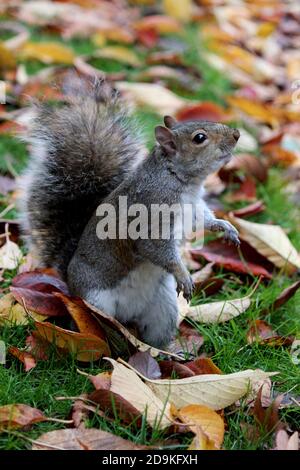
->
xmin=0 ymin=23 xmax=300 ymax=450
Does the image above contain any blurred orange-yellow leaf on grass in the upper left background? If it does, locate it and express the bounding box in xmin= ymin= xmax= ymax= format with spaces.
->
xmin=20 ymin=42 xmax=75 ymax=65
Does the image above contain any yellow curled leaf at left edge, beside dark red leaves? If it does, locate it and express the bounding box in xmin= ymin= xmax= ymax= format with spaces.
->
xmin=0 ymin=294 xmax=47 ymax=325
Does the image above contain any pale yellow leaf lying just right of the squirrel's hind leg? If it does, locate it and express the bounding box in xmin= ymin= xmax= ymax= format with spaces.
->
xmin=178 ymin=293 xmax=252 ymax=323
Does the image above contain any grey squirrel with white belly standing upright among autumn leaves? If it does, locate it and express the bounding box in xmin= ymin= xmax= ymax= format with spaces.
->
xmin=22 ymin=81 xmax=239 ymax=348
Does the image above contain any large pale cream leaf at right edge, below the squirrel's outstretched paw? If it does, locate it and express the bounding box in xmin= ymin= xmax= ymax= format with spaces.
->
xmin=230 ymin=214 xmax=300 ymax=274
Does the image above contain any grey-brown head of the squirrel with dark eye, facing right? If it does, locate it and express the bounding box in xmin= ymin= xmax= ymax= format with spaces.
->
xmin=155 ymin=116 xmax=240 ymax=177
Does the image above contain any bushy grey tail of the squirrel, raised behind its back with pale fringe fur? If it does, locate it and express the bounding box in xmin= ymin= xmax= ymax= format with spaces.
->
xmin=20 ymin=79 xmax=144 ymax=275
